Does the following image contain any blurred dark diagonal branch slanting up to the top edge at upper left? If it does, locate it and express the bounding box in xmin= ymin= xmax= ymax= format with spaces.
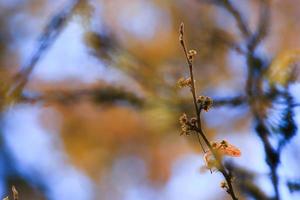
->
xmin=6 ymin=0 xmax=82 ymax=96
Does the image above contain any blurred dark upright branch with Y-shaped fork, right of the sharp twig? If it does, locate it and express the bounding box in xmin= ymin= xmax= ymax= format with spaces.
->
xmin=210 ymin=0 xmax=280 ymax=200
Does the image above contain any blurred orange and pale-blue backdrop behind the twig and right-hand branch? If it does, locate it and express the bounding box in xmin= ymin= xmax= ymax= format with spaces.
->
xmin=0 ymin=0 xmax=300 ymax=200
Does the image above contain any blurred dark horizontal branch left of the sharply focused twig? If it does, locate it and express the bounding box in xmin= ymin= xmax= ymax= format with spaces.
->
xmin=21 ymin=86 xmax=143 ymax=107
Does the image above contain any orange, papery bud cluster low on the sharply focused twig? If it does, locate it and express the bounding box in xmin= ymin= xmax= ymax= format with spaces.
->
xmin=203 ymin=140 xmax=241 ymax=170
